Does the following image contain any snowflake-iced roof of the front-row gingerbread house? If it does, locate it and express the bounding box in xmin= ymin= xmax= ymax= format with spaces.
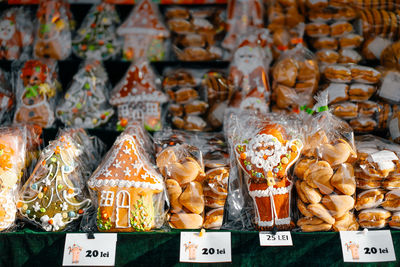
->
xmin=88 ymin=133 xmax=163 ymax=190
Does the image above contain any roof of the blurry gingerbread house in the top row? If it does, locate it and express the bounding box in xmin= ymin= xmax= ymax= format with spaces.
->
xmin=117 ymin=0 xmax=169 ymax=37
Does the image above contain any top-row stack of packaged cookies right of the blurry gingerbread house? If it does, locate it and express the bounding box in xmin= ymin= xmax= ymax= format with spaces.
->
xmin=165 ymin=7 xmax=225 ymax=61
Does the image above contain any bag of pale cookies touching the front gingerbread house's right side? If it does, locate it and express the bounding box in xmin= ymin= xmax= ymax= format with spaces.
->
xmin=156 ymin=140 xmax=206 ymax=229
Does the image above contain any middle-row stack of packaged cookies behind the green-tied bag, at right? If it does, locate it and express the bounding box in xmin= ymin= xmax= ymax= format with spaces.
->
xmin=323 ymin=64 xmax=391 ymax=133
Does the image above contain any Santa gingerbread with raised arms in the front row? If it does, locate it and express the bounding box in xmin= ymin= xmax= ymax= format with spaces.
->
xmin=235 ymin=124 xmax=303 ymax=230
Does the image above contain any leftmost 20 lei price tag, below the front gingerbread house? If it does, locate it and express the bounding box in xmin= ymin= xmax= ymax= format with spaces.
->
xmin=63 ymin=234 xmax=117 ymax=266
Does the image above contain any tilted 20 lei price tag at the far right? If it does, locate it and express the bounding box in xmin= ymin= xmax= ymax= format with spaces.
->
xmin=340 ymin=230 xmax=396 ymax=262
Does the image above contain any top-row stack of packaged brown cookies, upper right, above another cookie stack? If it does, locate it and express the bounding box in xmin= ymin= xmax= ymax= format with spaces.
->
xmin=305 ymin=1 xmax=363 ymax=65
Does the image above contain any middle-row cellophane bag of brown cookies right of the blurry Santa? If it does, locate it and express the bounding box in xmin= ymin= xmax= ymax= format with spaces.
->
xmin=272 ymin=44 xmax=320 ymax=110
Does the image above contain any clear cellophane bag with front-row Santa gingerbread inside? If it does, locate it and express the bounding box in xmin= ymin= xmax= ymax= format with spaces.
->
xmin=222 ymin=110 xmax=303 ymax=231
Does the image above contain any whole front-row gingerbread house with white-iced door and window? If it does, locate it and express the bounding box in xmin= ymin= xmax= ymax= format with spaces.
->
xmin=88 ymin=132 xmax=164 ymax=232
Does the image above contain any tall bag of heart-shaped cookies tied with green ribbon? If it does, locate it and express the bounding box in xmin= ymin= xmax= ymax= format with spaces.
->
xmin=294 ymin=93 xmax=358 ymax=232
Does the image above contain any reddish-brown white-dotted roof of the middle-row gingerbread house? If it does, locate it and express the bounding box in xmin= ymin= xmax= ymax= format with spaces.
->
xmin=110 ymin=60 xmax=167 ymax=106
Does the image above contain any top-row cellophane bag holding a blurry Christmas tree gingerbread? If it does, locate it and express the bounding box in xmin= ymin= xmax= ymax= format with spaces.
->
xmin=72 ymin=3 xmax=121 ymax=60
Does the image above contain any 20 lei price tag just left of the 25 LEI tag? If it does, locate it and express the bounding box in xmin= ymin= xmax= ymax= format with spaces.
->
xmin=179 ymin=232 xmax=232 ymax=263
